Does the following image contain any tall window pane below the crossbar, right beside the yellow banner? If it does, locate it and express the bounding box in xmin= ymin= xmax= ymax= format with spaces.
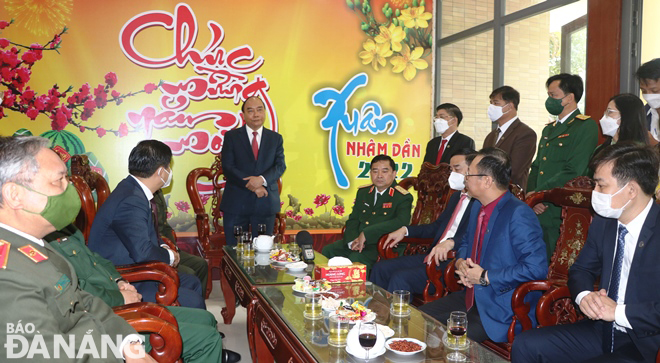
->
xmin=440 ymin=30 xmax=493 ymax=149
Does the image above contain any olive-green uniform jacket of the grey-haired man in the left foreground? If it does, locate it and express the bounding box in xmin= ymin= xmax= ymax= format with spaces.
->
xmin=0 ymin=228 xmax=137 ymax=362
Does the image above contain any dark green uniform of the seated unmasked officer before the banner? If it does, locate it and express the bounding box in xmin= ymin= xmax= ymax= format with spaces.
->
xmin=322 ymin=182 xmax=413 ymax=270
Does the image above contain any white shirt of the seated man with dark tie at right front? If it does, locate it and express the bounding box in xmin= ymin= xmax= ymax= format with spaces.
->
xmin=575 ymin=199 xmax=654 ymax=332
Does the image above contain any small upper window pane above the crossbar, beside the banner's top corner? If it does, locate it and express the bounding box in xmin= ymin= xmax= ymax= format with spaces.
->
xmin=439 ymin=0 xmax=495 ymax=38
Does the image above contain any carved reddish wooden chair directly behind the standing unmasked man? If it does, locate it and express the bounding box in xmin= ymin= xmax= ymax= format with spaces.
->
xmin=186 ymin=153 xmax=286 ymax=298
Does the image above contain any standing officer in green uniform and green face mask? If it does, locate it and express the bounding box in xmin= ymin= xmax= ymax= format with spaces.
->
xmin=527 ymin=73 xmax=598 ymax=261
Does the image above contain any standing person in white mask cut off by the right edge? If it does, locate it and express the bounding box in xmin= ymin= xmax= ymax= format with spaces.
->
xmin=635 ymin=58 xmax=660 ymax=145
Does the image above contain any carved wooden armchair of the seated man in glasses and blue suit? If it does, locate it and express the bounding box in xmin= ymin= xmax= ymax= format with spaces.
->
xmin=444 ymin=176 xmax=594 ymax=359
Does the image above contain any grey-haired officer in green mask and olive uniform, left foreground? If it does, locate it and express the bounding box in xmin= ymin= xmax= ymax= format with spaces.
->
xmin=0 ymin=137 xmax=155 ymax=363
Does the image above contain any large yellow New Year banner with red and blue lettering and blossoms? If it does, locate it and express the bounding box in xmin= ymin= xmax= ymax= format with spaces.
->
xmin=0 ymin=0 xmax=433 ymax=231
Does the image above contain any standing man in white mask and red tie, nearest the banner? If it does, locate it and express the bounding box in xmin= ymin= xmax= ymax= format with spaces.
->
xmin=424 ymin=103 xmax=474 ymax=165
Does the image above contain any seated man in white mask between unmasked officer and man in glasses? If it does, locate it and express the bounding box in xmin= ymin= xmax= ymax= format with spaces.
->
xmin=369 ymin=149 xmax=476 ymax=294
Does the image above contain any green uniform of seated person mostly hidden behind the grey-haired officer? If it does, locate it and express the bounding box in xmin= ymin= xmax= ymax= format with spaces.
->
xmin=44 ymin=225 xmax=222 ymax=363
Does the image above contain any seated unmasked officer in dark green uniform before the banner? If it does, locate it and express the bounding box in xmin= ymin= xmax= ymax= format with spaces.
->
xmin=322 ymin=155 xmax=413 ymax=270
